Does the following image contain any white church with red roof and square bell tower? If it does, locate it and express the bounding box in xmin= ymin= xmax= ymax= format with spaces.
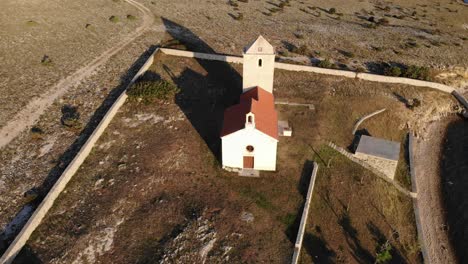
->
xmin=221 ymin=36 xmax=278 ymax=171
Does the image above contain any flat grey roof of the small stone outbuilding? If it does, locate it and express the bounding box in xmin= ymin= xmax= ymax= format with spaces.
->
xmin=356 ymin=135 xmax=400 ymax=161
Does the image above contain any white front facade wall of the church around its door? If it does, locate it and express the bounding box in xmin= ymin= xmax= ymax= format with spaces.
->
xmin=221 ymin=128 xmax=278 ymax=171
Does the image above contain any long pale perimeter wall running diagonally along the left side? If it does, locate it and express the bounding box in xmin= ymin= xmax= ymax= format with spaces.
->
xmin=0 ymin=49 xmax=158 ymax=264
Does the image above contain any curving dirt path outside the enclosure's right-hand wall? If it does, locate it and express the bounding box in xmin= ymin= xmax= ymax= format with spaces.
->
xmin=414 ymin=118 xmax=456 ymax=264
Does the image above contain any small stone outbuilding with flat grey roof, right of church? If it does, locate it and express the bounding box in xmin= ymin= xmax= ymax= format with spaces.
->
xmin=354 ymin=135 xmax=400 ymax=180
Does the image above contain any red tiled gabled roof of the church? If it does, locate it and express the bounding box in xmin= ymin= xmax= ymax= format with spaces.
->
xmin=221 ymin=87 xmax=278 ymax=139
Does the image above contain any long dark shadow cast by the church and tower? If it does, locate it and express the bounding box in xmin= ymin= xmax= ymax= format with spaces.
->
xmin=162 ymin=18 xmax=242 ymax=161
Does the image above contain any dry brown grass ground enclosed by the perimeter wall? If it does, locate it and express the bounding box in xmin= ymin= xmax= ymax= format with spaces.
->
xmin=7 ymin=54 xmax=454 ymax=263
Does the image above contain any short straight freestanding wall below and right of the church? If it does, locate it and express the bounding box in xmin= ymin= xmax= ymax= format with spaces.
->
xmin=291 ymin=162 xmax=318 ymax=264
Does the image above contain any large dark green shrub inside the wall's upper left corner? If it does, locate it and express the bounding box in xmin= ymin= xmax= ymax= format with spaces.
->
xmin=127 ymin=80 xmax=179 ymax=102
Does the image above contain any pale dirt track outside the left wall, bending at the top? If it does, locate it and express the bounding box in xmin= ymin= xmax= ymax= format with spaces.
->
xmin=0 ymin=0 xmax=154 ymax=149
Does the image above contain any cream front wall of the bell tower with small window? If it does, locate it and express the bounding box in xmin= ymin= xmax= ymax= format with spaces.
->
xmin=242 ymin=54 xmax=275 ymax=93
